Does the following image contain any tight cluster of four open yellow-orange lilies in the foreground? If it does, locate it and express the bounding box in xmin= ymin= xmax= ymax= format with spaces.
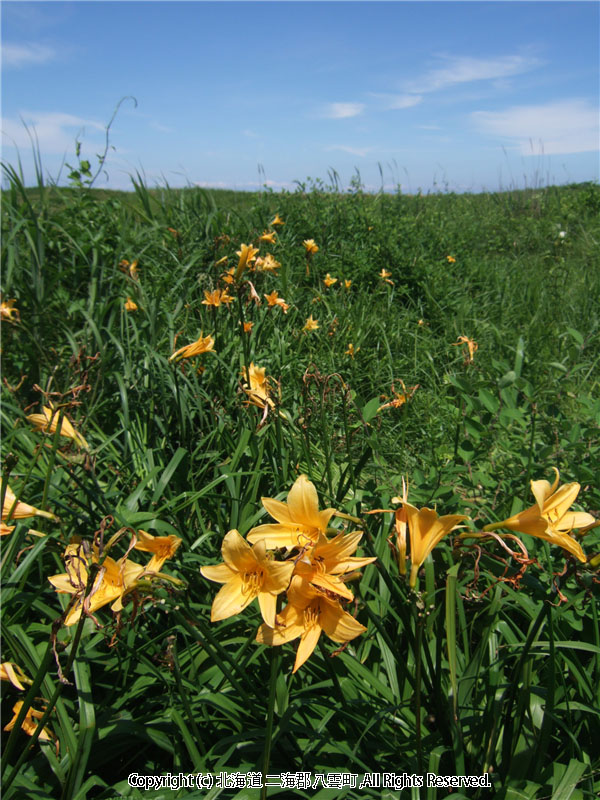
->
xmin=201 ymin=475 xmax=375 ymax=672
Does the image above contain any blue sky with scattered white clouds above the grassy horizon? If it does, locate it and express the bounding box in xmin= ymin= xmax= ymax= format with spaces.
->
xmin=1 ymin=0 xmax=600 ymax=192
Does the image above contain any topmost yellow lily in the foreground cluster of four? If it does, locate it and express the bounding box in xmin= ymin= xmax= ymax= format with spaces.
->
xmin=246 ymin=475 xmax=340 ymax=550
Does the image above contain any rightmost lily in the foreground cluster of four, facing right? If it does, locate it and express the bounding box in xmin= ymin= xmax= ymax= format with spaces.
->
xmin=294 ymin=531 xmax=377 ymax=600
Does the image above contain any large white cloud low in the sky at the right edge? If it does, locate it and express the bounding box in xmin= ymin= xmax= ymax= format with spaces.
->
xmin=471 ymin=99 xmax=600 ymax=155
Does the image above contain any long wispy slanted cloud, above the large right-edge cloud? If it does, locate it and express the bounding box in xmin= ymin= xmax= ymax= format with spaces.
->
xmin=405 ymin=56 xmax=540 ymax=93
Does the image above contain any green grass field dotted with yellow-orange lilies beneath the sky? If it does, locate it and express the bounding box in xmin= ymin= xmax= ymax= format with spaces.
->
xmin=1 ymin=170 xmax=600 ymax=800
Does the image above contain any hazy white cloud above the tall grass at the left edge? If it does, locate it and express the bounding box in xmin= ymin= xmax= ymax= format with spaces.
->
xmin=1 ymin=111 xmax=105 ymax=156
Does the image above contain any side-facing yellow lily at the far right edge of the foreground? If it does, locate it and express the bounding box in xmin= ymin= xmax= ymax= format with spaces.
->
xmin=483 ymin=467 xmax=596 ymax=562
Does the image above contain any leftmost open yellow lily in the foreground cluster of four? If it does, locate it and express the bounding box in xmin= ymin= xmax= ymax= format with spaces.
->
xmin=200 ymin=530 xmax=294 ymax=627
